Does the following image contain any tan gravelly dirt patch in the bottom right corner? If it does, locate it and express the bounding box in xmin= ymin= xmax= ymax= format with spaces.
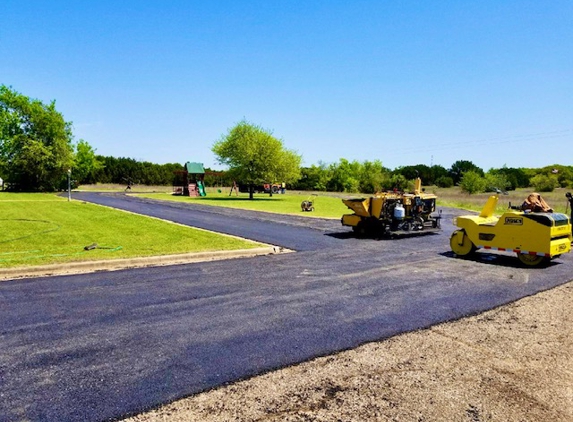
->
xmin=123 ymin=283 xmax=573 ymax=422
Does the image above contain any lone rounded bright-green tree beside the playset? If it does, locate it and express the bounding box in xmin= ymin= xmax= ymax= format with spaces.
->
xmin=211 ymin=120 xmax=302 ymax=199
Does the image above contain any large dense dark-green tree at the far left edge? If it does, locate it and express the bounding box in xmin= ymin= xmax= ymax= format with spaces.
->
xmin=0 ymin=85 xmax=73 ymax=191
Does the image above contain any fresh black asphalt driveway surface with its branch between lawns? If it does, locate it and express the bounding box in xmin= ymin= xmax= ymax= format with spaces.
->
xmin=0 ymin=193 xmax=573 ymax=422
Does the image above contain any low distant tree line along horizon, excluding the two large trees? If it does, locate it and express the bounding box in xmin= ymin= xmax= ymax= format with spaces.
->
xmin=63 ymin=155 xmax=573 ymax=194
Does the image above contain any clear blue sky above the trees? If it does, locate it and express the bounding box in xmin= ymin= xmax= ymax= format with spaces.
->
xmin=0 ymin=0 xmax=573 ymax=170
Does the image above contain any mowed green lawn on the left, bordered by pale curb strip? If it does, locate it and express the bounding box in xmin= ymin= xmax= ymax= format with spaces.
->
xmin=0 ymin=192 xmax=261 ymax=268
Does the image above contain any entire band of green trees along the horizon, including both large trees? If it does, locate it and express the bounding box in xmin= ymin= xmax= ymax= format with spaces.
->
xmin=0 ymin=85 xmax=573 ymax=194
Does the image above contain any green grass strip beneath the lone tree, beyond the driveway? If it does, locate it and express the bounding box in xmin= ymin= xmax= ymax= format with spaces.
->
xmin=137 ymin=188 xmax=352 ymax=219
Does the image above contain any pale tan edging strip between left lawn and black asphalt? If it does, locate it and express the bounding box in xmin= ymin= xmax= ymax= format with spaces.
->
xmin=0 ymin=246 xmax=294 ymax=281
